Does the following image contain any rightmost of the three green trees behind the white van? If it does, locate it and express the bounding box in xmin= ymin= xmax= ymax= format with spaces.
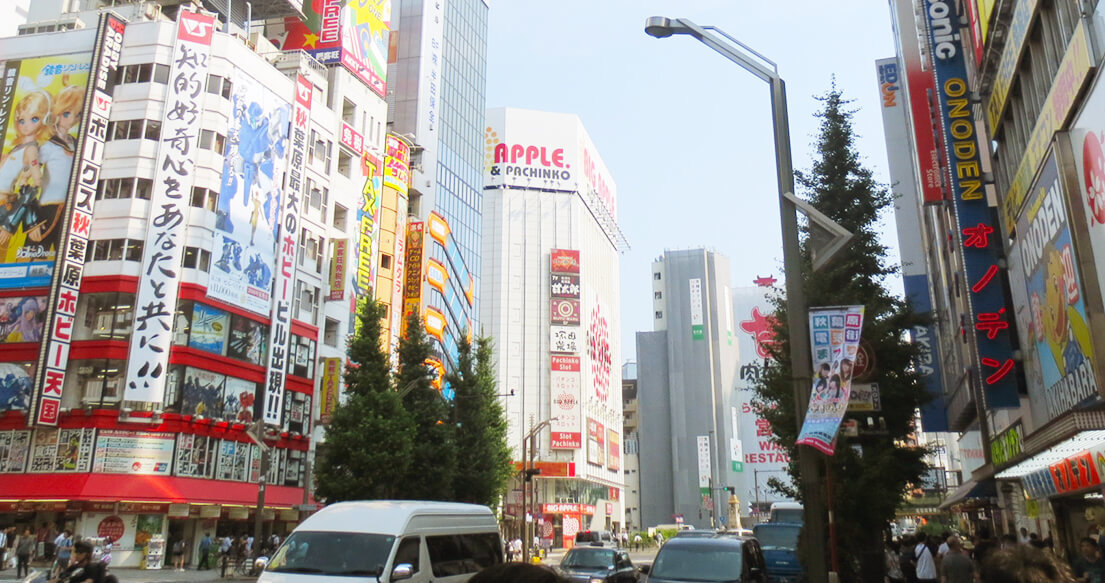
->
xmin=449 ymin=337 xmax=514 ymax=508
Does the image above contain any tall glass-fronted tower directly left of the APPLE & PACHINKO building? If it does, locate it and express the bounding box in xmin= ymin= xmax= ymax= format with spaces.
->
xmin=388 ymin=0 xmax=488 ymax=370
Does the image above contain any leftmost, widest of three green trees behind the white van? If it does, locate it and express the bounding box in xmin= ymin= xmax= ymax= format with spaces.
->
xmin=315 ymin=301 xmax=415 ymax=504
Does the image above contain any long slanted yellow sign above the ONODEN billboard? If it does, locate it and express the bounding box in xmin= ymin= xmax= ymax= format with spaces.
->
xmin=1002 ymin=22 xmax=1093 ymax=227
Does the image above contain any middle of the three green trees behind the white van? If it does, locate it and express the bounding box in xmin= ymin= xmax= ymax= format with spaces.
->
xmin=396 ymin=314 xmax=456 ymax=500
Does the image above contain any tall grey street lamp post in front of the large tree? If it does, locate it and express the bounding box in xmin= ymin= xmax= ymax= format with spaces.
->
xmin=644 ymin=17 xmax=829 ymax=583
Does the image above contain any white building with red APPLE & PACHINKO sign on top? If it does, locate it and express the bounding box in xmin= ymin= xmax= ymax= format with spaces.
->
xmin=480 ymin=108 xmax=624 ymax=547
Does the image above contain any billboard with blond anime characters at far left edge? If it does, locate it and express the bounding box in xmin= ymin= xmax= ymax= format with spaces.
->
xmin=0 ymin=53 xmax=92 ymax=287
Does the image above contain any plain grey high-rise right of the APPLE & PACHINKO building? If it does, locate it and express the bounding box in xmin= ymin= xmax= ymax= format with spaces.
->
xmin=636 ymin=248 xmax=741 ymax=528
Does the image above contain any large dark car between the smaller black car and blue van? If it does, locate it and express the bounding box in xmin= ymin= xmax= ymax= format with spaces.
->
xmin=642 ymin=536 xmax=767 ymax=583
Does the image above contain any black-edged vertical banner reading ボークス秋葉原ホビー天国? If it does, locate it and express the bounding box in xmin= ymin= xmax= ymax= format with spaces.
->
xmin=27 ymin=14 xmax=126 ymax=425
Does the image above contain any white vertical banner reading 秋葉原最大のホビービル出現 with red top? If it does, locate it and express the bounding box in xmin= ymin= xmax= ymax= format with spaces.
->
xmin=260 ymin=75 xmax=314 ymax=425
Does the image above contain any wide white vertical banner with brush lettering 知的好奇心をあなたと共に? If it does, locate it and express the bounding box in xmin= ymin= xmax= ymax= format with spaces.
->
xmin=123 ymin=10 xmax=214 ymax=403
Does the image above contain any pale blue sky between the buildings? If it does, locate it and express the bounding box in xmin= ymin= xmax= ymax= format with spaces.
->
xmin=487 ymin=0 xmax=898 ymax=360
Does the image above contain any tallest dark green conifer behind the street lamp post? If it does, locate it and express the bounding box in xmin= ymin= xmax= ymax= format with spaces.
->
xmin=757 ymin=85 xmax=926 ymax=582
